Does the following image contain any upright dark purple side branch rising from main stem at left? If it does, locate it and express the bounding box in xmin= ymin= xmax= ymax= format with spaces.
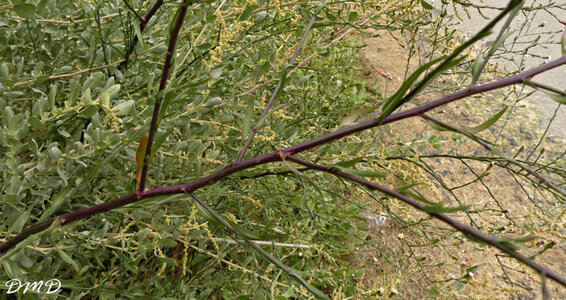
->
xmin=138 ymin=0 xmax=193 ymax=193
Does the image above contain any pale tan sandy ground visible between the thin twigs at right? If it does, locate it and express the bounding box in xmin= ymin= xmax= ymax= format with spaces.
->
xmin=355 ymin=20 xmax=566 ymax=299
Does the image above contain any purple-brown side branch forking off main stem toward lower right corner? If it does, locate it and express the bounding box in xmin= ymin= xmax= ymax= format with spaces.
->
xmin=283 ymin=153 xmax=566 ymax=287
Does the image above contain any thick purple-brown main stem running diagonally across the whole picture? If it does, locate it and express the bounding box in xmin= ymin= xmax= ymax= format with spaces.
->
xmin=0 ymin=56 xmax=566 ymax=285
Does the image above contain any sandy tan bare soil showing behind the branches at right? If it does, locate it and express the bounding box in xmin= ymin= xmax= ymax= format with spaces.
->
xmin=352 ymin=31 xmax=566 ymax=299
